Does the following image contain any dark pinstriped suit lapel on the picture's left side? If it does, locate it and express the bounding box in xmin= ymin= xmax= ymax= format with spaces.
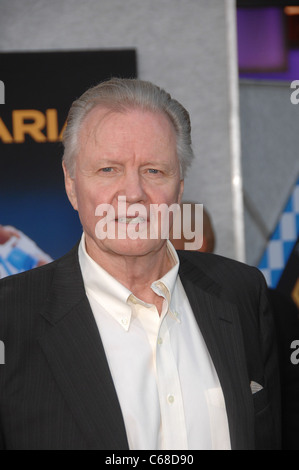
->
xmin=40 ymin=247 xmax=128 ymax=450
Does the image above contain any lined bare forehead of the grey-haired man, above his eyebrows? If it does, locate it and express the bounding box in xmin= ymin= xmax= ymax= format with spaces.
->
xmin=80 ymin=106 xmax=176 ymax=150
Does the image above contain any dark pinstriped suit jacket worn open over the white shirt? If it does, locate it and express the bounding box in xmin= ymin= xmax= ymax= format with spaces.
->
xmin=0 ymin=247 xmax=280 ymax=450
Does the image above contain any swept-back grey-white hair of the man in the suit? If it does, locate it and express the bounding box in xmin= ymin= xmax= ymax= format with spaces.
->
xmin=63 ymin=78 xmax=194 ymax=178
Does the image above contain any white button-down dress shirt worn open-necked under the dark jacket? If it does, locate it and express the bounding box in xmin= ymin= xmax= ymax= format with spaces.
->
xmin=79 ymin=234 xmax=231 ymax=450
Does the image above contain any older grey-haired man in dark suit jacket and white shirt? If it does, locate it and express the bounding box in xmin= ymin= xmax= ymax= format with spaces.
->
xmin=0 ymin=79 xmax=280 ymax=450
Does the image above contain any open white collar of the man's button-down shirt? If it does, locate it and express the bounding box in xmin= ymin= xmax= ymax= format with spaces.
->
xmin=78 ymin=233 xmax=179 ymax=331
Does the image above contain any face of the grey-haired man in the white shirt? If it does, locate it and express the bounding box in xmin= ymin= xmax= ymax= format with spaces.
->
xmin=65 ymin=107 xmax=183 ymax=256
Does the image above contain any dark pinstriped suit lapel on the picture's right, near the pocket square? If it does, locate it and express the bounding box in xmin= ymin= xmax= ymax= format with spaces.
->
xmin=180 ymin=256 xmax=254 ymax=449
